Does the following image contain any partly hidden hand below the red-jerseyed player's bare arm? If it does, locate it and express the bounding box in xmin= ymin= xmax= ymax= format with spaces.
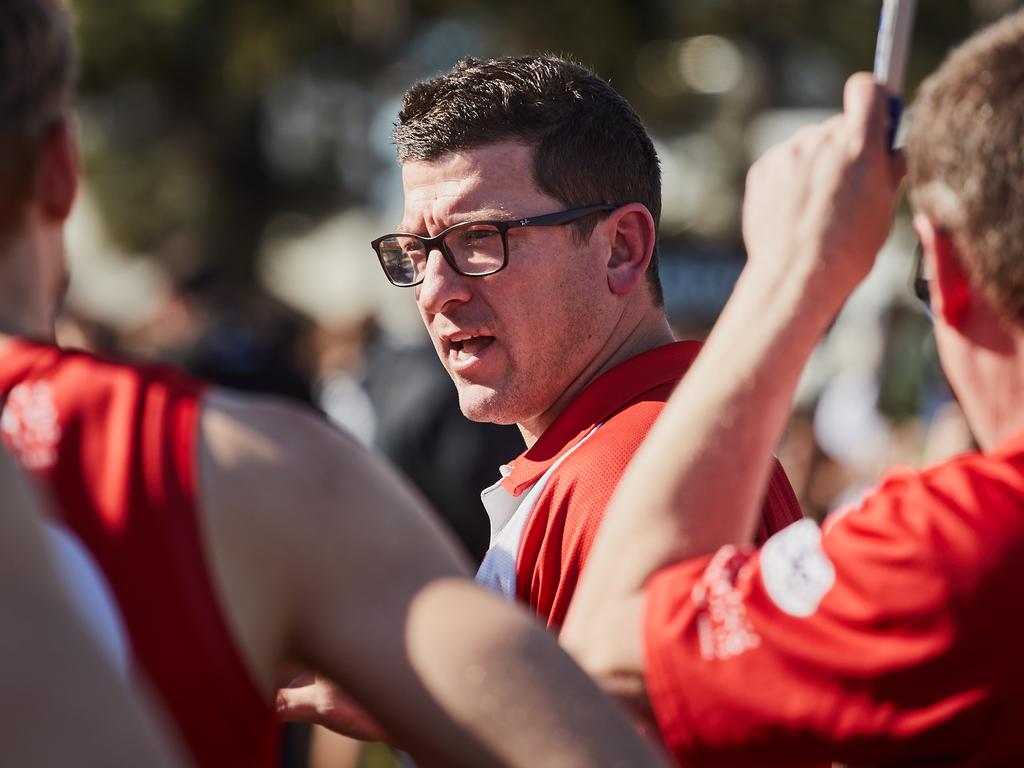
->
xmin=276 ymin=674 xmax=390 ymax=741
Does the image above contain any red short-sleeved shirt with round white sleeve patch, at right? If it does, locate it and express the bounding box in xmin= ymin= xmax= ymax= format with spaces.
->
xmin=644 ymin=435 xmax=1024 ymax=766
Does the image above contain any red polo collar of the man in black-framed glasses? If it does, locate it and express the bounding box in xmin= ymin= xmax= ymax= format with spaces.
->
xmin=502 ymin=341 xmax=700 ymax=496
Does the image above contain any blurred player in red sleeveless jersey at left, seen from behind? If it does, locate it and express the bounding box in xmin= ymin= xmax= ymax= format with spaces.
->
xmin=0 ymin=0 xmax=659 ymax=768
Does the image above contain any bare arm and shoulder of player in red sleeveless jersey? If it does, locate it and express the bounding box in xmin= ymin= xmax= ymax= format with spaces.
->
xmin=202 ymin=395 xmax=662 ymax=766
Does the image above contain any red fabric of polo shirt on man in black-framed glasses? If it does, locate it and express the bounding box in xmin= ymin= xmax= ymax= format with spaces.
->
xmin=502 ymin=341 xmax=802 ymax=628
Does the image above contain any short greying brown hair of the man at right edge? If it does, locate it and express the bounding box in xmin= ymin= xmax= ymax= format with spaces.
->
xmin=906 ymin=11 xmax=1024 ymax=324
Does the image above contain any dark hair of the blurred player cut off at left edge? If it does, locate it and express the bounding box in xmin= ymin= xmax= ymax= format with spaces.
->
xmin=0 ymin=0 xmax=75 ymax=221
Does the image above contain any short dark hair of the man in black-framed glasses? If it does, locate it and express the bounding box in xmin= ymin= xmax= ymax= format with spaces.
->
xmin=393 ymin=56 xmax=663 ymax=304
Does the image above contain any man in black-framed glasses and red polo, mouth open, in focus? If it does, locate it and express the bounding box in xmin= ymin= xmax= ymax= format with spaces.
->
xmin=373 ymin=57 xmax=799 ymax=628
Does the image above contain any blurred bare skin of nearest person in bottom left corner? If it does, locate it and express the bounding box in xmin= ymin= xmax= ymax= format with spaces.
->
xmin=0 ymin=451 xmax=177 ymax=768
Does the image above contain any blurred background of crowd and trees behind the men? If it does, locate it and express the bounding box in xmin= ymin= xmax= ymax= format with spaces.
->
xmin=59 ymin=0 xmax=1007 ymax=768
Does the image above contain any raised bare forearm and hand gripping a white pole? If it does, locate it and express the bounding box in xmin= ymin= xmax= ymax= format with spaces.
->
xmin=562 ymin=76 xmax=902 ymax=694
